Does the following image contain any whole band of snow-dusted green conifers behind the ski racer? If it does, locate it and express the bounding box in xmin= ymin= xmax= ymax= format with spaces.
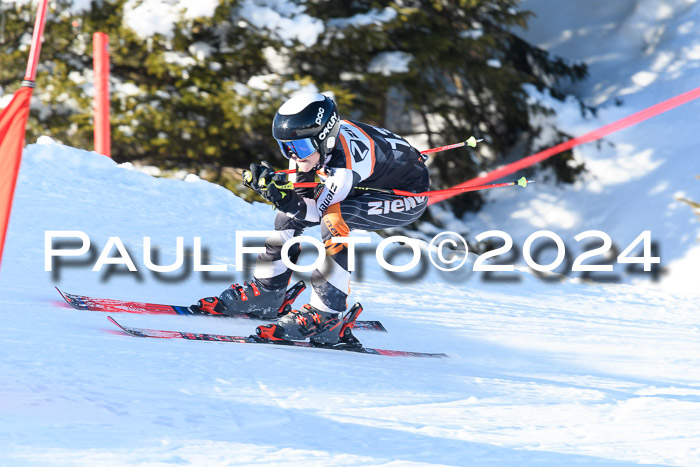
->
xmin=0 ymin=0 xmax=586 ymax=212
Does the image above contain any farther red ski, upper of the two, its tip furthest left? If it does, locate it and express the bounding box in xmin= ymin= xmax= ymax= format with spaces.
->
xmin=56 ymin=281 xmax=387 ymax=332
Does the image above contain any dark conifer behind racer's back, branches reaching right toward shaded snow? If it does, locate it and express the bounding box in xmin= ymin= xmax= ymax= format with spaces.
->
xmin=292 ymin=0 xmax=586 ymax=211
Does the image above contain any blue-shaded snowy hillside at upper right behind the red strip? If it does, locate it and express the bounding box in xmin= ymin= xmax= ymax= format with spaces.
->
xmin=482 ymin=0 xmax=700 ymax=293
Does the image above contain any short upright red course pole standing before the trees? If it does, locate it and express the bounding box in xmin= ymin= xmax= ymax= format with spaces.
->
xmin=92 ymin=32 xmax=112 ymax=157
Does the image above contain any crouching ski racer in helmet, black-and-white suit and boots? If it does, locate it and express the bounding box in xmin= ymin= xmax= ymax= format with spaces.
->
xmin=190 ymin=93 xmax=430 ymax=345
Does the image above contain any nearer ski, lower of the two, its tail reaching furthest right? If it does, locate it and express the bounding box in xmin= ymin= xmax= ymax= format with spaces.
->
xmin=107 ymin=316 xmax=447 ymax=358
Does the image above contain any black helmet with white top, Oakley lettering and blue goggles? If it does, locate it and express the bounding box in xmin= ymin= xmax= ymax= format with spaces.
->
xmin=272 ymin=93 xmax=340 ymax=162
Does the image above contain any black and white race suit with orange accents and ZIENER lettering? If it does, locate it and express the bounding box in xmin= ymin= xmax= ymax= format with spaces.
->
xmin=255 ymin=120 xmax=430 ymax=312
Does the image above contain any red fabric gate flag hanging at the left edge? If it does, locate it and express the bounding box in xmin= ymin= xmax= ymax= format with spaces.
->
xmin=0 ymin=86 xmax=32 ymax=261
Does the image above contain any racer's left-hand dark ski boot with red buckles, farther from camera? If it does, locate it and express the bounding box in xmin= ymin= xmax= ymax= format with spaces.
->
xmin=189 ymin=280 xmax=306 ymax=319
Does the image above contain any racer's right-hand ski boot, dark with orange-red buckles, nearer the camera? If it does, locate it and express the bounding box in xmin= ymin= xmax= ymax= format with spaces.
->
xmin=255 ymin=303 xmax=362 ymax=348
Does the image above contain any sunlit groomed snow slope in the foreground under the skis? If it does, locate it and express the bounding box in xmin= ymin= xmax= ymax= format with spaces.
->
xmin=0 ymin=141 xmax=700 ymax=465
